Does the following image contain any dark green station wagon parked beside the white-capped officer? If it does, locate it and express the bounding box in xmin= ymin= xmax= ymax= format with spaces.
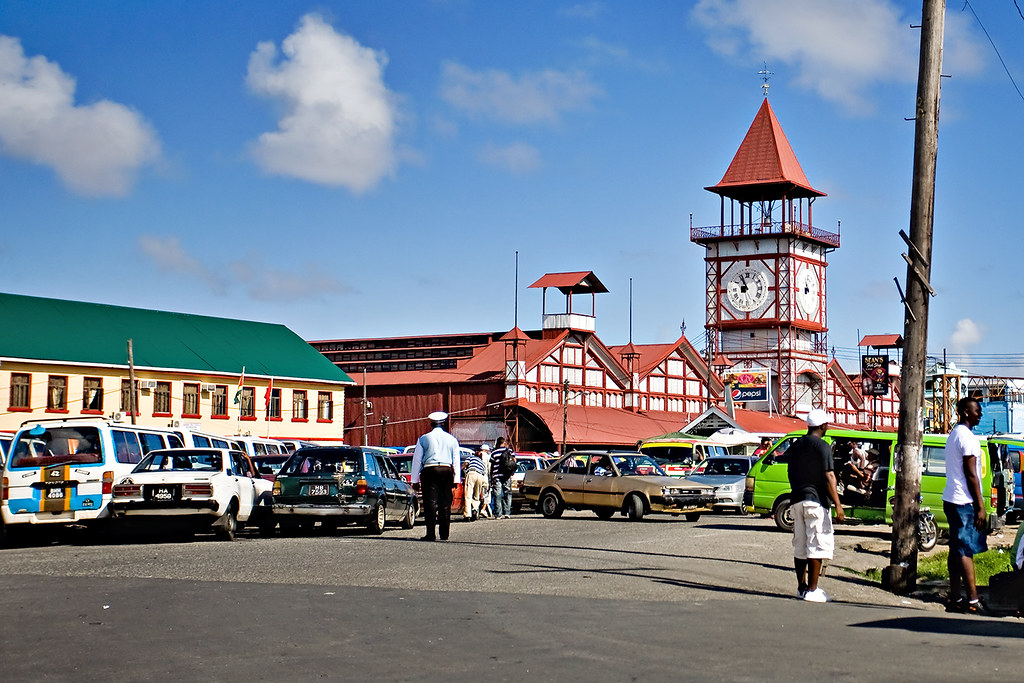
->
xmin=273 ymin=445 xmax=417 ymax=533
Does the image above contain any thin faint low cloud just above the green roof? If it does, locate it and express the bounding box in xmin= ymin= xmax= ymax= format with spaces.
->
xmin=138 ymin=234 xmax=355 ymax=301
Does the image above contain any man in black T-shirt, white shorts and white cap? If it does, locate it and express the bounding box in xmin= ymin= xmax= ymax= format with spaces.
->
xmin=787 ymin=408 xmax=846 ymax=602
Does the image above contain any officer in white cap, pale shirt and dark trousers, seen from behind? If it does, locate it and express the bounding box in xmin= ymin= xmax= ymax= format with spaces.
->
xmin=412 ymin=411 xmax=462 ymax=541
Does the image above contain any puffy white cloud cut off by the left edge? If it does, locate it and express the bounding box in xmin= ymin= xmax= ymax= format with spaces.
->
xmin=0 ymin=36 xmax=160 ymax=197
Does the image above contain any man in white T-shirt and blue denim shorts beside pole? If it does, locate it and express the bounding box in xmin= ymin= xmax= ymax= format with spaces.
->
xmin=942 ymin=396 xmax=988 ymax=613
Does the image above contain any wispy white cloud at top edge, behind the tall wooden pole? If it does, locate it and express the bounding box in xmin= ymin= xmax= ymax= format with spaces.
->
xmin=691 ymin=0 xmax=980 ymax=114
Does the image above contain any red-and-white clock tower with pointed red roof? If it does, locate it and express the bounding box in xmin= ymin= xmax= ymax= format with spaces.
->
xmin=690 ymin=97 xmax=840 ymax=415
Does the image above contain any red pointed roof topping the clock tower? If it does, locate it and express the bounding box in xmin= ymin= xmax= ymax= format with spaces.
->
xmin=705 ymin=98 xmax=825 ymax=202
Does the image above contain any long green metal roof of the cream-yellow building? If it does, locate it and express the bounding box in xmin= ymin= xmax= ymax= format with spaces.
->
xmin=0 ymin=293 xmax=354 ymax=383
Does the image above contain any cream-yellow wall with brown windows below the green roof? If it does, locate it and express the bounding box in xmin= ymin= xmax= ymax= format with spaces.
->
xmin=0 ymin=359 xmax=345 ymax=442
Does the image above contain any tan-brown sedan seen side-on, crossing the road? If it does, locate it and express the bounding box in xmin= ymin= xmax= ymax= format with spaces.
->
xmin=523 ymin=451 xmax=715 ymax=521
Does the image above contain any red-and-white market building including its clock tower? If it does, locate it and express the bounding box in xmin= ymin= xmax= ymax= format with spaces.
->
xmin=310 ymin=99 xmax=899 ymax=451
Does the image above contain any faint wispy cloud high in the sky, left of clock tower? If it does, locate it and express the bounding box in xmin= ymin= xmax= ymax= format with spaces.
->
xmin=441 ymin=61 xmax=602 ymax=124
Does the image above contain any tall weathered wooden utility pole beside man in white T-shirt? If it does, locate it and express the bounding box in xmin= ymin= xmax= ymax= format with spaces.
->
xmin=882 ymin=0 xmax=946 ymax=595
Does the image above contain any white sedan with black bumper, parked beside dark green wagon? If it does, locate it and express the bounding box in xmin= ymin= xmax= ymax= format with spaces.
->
xmin=111 ymin=449 xmax=273 ymax=541
